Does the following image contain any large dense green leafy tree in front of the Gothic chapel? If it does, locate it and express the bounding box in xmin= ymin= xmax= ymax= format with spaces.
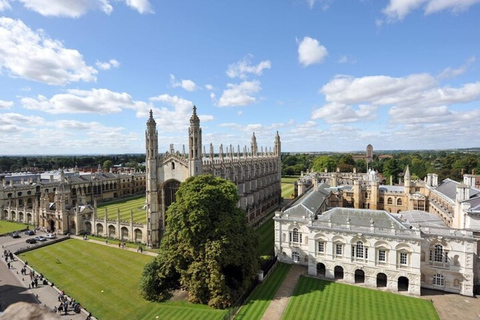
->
xmin=140 ymin=175 xmax=258 ymax=308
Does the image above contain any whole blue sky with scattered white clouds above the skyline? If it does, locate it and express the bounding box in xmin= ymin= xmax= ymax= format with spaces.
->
xmin=0 ymin=0 xmax=480 ymax=155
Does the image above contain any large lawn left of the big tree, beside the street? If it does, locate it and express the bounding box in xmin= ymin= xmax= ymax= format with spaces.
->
xmin=20 ymin=239 xmax=225 ymax=320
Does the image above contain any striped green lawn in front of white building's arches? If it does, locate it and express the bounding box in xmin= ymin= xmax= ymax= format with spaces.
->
xmin=282 ymin=277 xmax=439 ymax=320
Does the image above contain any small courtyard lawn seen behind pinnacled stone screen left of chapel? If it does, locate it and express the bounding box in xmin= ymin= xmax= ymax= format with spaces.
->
xmin=97 ymin=197 xmax=147 ymax=223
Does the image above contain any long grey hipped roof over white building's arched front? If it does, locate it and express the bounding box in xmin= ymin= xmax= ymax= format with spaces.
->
xmin=313 ymin=207 xmax=408 ymax=230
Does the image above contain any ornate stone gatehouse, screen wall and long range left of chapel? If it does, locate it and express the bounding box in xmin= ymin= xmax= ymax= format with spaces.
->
xmin=0 ymin=167 xmax=146 ymax=242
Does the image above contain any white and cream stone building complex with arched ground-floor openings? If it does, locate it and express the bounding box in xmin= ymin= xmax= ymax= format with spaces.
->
xmin=274 ymin=168 xmax=480 ymax=296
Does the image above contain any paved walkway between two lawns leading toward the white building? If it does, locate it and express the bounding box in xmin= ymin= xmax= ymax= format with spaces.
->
xmin=262 ymin=264 xmax=307 ymax=320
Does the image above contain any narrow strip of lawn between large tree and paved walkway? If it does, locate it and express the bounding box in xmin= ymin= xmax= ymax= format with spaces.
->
xmin=235 ymin=263 xmax=291 ymax=320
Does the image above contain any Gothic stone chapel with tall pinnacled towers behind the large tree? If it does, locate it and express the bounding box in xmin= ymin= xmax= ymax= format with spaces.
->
xmin=145 ymin=106 xmax=281 ymax=247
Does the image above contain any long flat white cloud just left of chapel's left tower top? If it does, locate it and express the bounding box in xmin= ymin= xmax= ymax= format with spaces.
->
xmin=21 ymin=89 xmax=144 ymax=114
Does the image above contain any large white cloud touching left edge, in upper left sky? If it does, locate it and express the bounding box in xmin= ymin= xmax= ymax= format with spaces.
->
xmin=0 ymin=17 xmax=97 ymax=85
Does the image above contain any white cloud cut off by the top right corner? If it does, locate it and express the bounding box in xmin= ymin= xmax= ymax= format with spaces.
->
xmin=382 ymin=0 xmax=480 ymax=22
